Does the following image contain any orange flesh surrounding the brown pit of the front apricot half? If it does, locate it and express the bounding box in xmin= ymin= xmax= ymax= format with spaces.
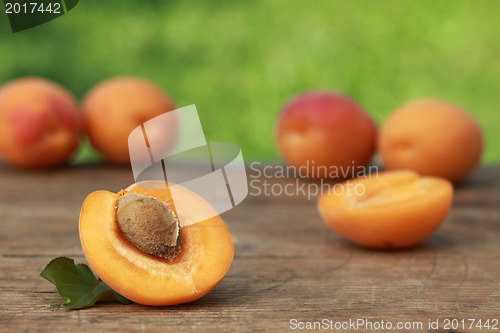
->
xmin=80 ymin=183 xmax=234 ymax=305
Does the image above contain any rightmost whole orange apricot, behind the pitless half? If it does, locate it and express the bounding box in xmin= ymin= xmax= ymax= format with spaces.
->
xmin=378 ymin=100 xmax=483 ymax=183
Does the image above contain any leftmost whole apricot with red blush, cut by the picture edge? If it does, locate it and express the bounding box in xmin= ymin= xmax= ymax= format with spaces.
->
xmin=0 ymin=77 xmax=82 ymax=169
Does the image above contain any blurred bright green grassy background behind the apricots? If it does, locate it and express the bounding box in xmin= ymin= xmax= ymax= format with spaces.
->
xmin=0 ymin=0 xmax=500 ymax=163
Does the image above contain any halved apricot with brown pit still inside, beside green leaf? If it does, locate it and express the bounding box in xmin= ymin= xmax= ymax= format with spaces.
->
xmin=80 ymin=182 xmax=234 ymax=305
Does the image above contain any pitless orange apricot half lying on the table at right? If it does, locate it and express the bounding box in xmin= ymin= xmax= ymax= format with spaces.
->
xmin=318 ymin=170 xmax=453 ymax=249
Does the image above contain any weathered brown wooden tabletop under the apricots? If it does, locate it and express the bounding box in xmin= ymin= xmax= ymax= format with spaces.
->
xmin=0 ymin=166 xmax=500 ymax=332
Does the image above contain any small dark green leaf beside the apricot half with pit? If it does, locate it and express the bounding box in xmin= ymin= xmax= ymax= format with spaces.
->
xmin=40 ymin=257 xmax=131 ymax=309
